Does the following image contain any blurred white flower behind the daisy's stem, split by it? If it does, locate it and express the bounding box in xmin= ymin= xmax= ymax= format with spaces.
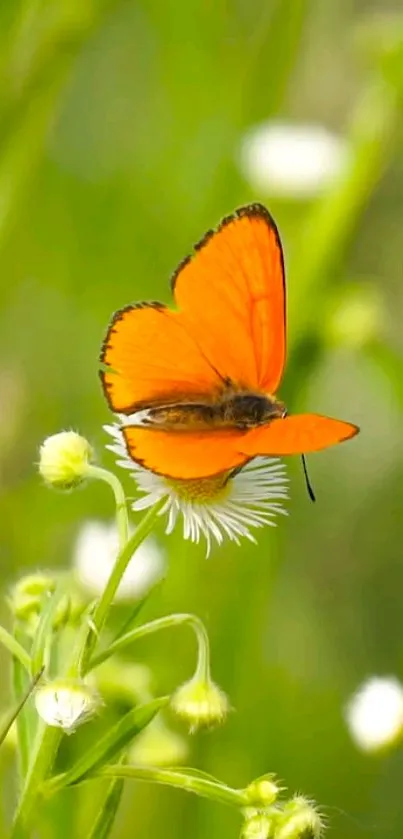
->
xmin=73 ymin=520 xmax=166 ymax=600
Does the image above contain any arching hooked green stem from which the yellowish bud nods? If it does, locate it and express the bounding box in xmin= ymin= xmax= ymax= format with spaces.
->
xmin=86 ymin=613 xmax=210 ymax=679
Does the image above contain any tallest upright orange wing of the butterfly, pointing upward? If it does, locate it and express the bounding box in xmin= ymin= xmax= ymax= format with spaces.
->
xmin=172 ymin=204 xmax=285 ymax=393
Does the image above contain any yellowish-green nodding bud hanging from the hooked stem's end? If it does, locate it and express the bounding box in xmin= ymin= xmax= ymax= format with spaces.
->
xmin=171 ymin=676 xmax=229 ymax=732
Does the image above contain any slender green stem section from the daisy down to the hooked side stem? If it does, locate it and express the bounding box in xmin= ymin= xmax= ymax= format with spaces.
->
xmin=82 ymin=498 xmax=165 ymax=673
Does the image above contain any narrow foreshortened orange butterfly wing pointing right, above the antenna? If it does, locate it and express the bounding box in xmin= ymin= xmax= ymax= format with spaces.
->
xmin=240 ymin=414 xmax=359 ymax=457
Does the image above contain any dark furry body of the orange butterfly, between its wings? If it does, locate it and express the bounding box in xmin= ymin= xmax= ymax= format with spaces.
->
xmin=131 ymin=389 xmax=286 ymax=433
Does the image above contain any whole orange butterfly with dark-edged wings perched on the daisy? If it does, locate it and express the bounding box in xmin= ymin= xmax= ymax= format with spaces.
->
xmin=101 ymin=204 xmax=359 ymax=480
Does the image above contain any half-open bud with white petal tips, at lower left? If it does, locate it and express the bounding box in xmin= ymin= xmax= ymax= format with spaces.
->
xmin=35 ymin=679 xmax=100 ymax=734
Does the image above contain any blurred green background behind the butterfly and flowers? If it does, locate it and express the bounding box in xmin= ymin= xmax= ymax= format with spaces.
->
xmin=0 ymin=0 xmax=403 ymax=839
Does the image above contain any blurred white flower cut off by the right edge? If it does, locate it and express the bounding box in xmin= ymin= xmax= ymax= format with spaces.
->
xmin=345 ymin=676 xmax=403 ymax=752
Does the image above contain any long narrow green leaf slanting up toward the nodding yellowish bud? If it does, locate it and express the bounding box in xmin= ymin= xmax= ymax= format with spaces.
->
xmin=45 ymin=696 xmax=170 ymax=793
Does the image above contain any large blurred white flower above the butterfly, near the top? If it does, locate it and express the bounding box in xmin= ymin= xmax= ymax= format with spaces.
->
xmin=239 ymin=121 xmax=348 ymax=199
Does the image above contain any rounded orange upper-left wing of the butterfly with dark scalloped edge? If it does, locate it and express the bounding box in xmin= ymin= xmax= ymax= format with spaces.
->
xmin=100 ymin=303 xmax=223 ymax=414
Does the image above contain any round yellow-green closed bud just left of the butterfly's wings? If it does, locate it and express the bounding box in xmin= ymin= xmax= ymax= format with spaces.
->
xmin=39 ymin=431 xmax=93 ymax=489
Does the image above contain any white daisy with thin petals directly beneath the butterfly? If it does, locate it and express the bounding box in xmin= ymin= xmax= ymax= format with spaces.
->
xmin=104 ymin=424 xmax=288 ymax=556
